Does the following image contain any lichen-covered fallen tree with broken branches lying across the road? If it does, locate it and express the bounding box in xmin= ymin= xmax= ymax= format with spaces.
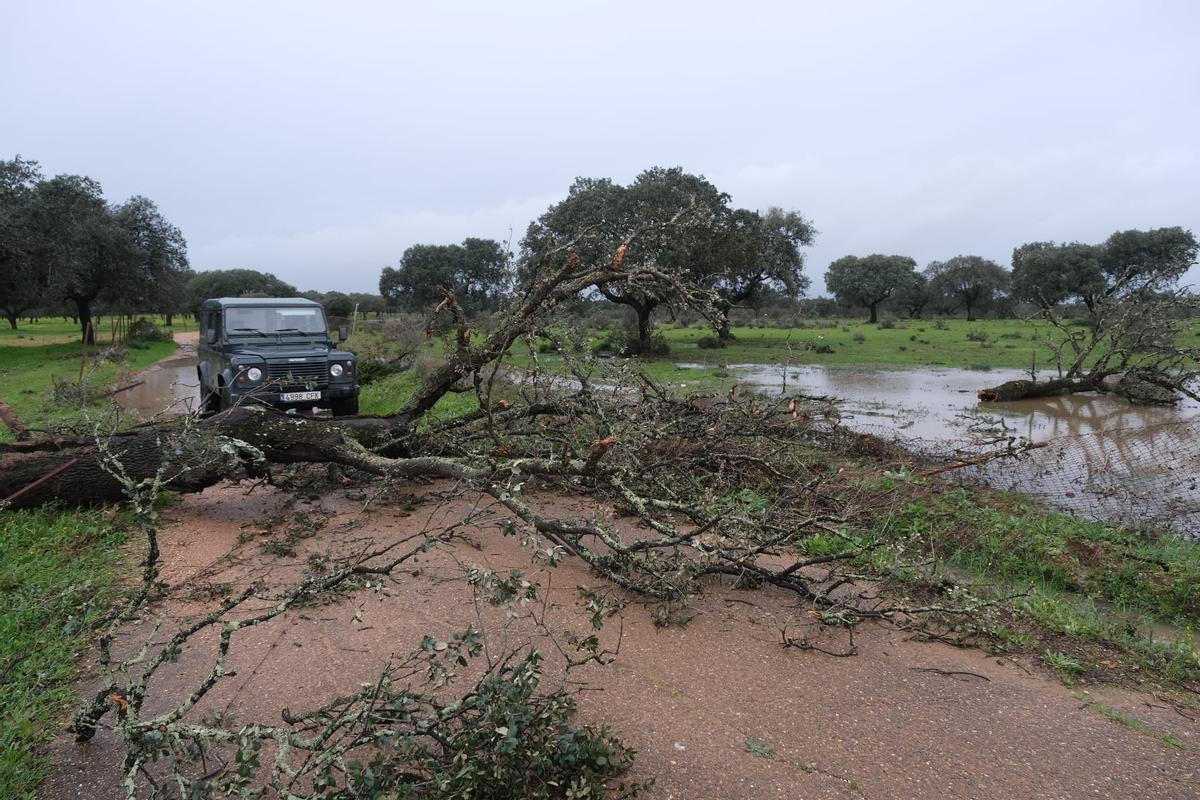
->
xmin=0 ymin=199 xmax=1041 ymax=798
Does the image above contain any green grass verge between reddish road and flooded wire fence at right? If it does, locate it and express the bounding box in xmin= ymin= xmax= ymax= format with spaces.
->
xmin=871 ymin=488 xmax=1200 ymax=682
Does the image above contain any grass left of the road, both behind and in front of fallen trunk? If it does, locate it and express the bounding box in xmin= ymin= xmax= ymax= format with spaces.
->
xmin=0 ymin=319 xmax=182 ymax=799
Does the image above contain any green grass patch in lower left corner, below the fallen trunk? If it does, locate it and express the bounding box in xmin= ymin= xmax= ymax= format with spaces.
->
xmin=0 ymin=509 xmax=125 ymax=799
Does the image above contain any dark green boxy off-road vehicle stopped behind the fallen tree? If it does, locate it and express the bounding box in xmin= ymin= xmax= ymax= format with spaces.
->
xmin=197 ymin=297 xmax=359 ymax=416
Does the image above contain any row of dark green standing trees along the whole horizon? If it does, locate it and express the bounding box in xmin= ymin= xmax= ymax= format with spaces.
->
xmin=7 ymin=156 xmax=1196 ymax=351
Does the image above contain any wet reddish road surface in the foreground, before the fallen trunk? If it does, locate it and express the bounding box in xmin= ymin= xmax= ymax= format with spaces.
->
xmin=42 ymin=486 xmax=1200 ymax=800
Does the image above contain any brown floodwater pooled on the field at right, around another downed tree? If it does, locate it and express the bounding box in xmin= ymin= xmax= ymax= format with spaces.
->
xmin=680 ymin=365 xmax=1200 ymax=536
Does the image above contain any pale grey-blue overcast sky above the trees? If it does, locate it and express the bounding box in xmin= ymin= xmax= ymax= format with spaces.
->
xmin=0 ymin=0 xmax=1200 ymax=291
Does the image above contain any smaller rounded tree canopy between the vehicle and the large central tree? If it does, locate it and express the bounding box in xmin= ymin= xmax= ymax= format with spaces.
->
xmin=379 ymin=239 xmax=511 ymax=311
